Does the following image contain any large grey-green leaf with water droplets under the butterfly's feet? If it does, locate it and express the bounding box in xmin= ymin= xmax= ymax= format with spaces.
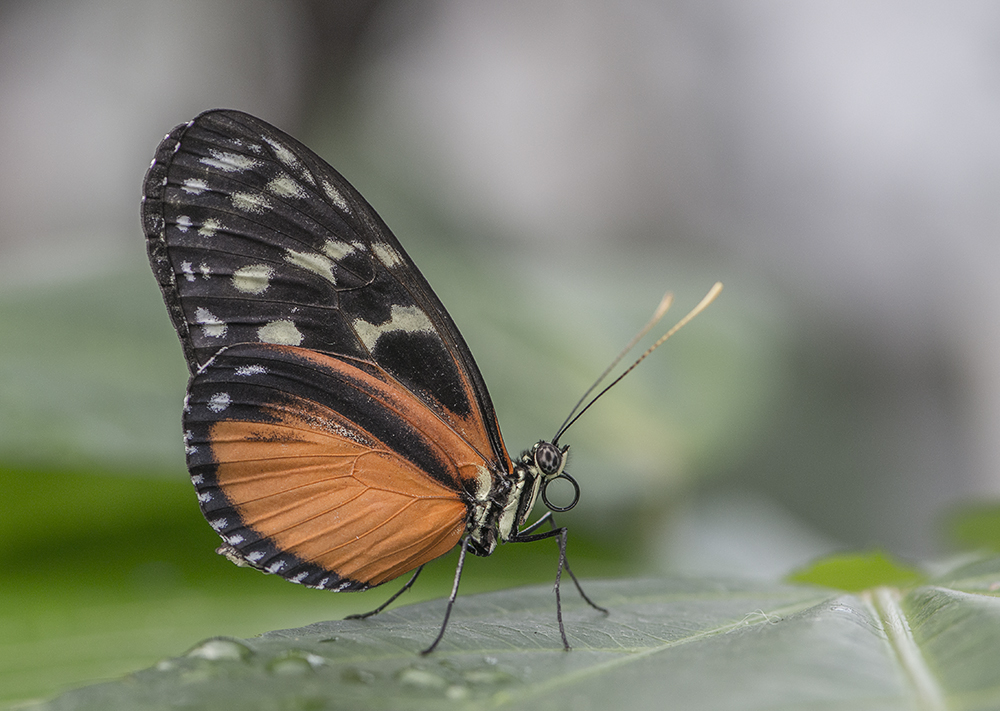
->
xmin=25 ymin=558 xmax=1000 ymax=711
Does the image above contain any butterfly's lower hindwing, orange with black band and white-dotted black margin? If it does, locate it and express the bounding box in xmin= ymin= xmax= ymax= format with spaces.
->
xmin=185 ymin=344 xmax=498 ymax=590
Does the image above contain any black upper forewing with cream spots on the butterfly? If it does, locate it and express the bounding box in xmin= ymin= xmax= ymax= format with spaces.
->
xmin=142 ymin=110 xmax=510 ymax=471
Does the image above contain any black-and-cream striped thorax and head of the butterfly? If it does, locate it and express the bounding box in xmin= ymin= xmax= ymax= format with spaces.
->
xmin=468 ymin=440 xmax=569 ymax=556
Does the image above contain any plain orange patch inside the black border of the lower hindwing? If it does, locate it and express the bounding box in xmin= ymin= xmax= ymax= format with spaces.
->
xmin=210 ymin=406 xmax=467 ymax=585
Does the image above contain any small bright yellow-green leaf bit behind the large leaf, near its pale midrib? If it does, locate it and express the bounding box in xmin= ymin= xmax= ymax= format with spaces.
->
xmin=789 ymin=551 xmax=924 ymax=592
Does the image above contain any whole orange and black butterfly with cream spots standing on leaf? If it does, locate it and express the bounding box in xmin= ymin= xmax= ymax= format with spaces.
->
xmin=142 ymin=110 xmax=720 ymax=653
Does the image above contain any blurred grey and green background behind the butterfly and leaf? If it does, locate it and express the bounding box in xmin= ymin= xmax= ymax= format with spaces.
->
xmin=0 ymin=0 xmax=1000 ymax=703
